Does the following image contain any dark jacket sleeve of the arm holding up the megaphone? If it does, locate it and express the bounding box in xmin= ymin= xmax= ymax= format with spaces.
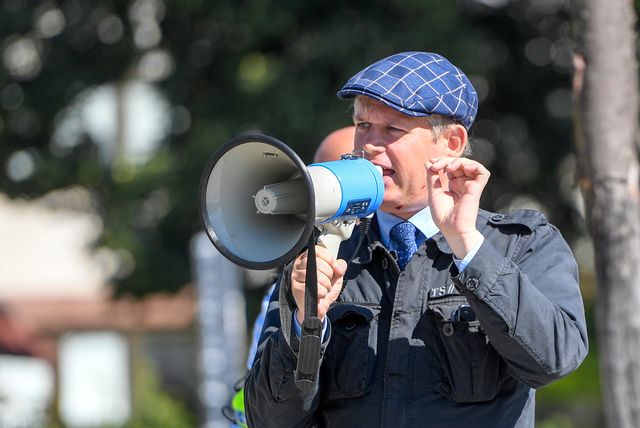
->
xmin=245 ymin=268 xmax=330 ymax=428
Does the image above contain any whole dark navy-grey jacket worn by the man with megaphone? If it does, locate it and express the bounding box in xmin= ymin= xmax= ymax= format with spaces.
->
xmin=245 ymin=210 xmax=587 ymax=428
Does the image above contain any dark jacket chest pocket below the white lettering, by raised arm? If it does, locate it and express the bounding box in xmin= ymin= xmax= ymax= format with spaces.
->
xmin=428 ymin=296 xmax=506 ymax=403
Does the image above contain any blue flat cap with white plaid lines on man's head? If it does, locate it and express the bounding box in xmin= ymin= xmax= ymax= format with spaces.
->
xmin=338 ymin=52 xmax=478 ymax=129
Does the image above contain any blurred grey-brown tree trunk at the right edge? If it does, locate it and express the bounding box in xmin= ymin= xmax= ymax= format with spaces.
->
xmin=573 ymin=0 xmax=640 ymax=428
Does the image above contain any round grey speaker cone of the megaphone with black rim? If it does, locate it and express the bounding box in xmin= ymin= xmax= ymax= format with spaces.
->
xmin=200 ymin=134 xmax=315 ymax=269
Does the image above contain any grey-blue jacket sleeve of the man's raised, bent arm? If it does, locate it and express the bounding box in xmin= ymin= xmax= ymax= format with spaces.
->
xmin=454 ymin=219 xmax=588 ymax=388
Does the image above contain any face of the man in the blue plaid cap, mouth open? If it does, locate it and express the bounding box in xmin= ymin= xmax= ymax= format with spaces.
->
xmin=353 ymin=97 xmax=452 ymax=219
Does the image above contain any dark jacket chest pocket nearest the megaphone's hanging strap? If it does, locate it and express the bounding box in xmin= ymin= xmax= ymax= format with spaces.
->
xmin=321 ymin=303 xmax=380 ymax=400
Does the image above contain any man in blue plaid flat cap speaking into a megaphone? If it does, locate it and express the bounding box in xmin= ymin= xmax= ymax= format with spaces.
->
xmin=245 ymin=52 xmax=587 ymax=427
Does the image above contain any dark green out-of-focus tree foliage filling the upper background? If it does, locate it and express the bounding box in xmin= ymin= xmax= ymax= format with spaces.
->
xmin=0 ymin=0 xmax=582 ymax=296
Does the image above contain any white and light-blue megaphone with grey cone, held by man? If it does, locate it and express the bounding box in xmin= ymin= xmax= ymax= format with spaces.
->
xmin=200 ymin=134 xmax=384 ymax=269
